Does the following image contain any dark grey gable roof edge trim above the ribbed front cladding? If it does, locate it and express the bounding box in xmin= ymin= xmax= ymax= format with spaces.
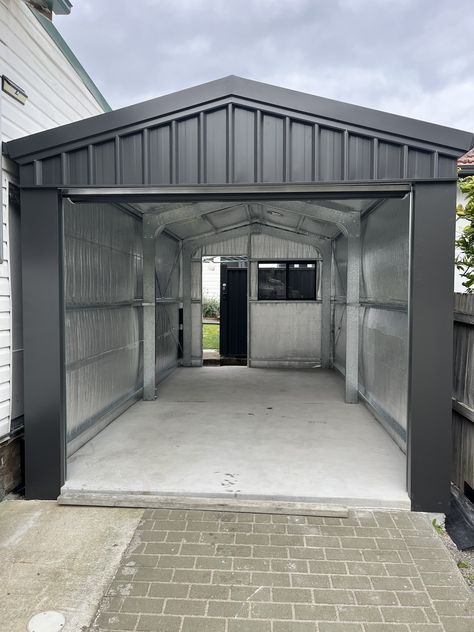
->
xmin=7 ymin=76 xmax=474 ymax=163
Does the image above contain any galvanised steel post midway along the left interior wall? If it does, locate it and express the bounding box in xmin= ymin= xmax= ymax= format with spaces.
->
xmin=143 ymin=215 xmax=157 ymax=401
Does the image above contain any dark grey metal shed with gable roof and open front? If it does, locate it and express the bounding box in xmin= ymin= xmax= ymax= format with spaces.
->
xmin=7 ymin=76 xmax=474 ymax=511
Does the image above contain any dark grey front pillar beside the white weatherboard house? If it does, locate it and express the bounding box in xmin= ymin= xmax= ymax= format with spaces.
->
xmin=21 ymin=189 xmax=66 ymax=500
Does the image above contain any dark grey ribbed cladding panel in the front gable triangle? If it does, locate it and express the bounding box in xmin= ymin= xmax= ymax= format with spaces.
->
xmin=22 ymin=99 xmax=456 ymax=186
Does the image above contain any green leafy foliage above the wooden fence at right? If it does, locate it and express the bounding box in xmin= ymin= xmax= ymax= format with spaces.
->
xmin=455 ymin=176 xmax=474 ymax=293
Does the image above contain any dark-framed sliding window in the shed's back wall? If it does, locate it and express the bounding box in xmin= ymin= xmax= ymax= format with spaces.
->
xmin=258 ymin=261 xmax=316 ymax=301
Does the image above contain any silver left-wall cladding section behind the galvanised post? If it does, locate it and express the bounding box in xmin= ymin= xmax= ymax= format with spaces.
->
xmin=155 ymin=233 xmax=181 ymax=381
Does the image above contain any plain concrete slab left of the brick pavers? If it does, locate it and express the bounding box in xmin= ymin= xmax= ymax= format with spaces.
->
xmin=0 ymin=500 xmax=143 ymax=632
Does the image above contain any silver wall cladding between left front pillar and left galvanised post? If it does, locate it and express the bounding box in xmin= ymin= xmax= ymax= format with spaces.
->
xmin=64 ymin=201 xmax=143 ymax=451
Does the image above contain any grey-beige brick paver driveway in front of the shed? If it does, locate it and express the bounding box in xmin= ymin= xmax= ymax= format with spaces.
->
xmin=91 ymin=510 xmax=474 ymax=632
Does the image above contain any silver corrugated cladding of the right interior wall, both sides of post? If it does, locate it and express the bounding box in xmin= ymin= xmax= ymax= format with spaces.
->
xmin=333 ymin=199 xmax=409 ymax=447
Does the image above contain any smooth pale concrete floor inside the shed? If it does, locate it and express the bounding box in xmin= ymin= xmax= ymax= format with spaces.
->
xmin=63 ymin=367 xmax=410 ymax=508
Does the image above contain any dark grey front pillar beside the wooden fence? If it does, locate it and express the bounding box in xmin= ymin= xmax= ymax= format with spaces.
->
xmin=407 ymin=182 xmax=456 ymax=513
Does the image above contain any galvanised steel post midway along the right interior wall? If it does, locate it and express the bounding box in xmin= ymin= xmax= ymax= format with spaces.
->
xmin=345 ymin=218 xmax=361 ymax=404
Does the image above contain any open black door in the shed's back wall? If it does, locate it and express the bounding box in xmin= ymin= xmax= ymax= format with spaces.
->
xmin=220 ymin=263 xmax=247 ymax=358
